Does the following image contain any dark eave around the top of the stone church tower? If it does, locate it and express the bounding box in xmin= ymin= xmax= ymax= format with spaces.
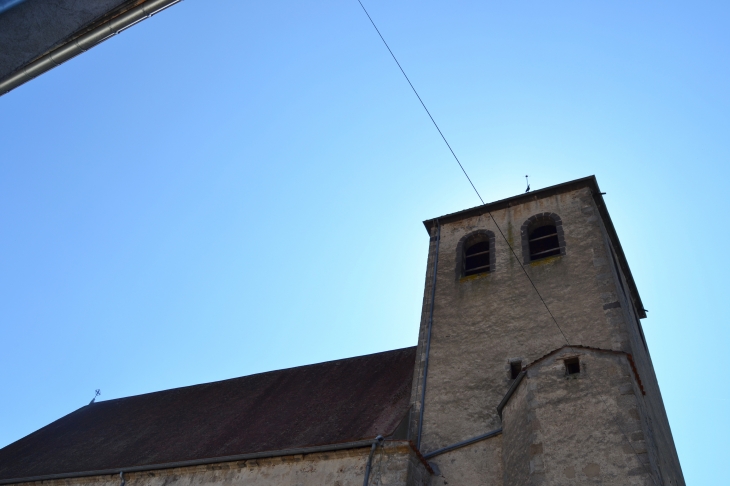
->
xmin=423 ymin=175 xmax=646 ymax=319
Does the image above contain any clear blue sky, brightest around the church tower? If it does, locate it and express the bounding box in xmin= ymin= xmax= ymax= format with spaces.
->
xmin=0 ymin=0 xmax=730 ymax=484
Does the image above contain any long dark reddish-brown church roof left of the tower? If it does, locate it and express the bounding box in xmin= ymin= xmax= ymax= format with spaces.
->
xmin=0 ymin=347 xmax=416 ymax=480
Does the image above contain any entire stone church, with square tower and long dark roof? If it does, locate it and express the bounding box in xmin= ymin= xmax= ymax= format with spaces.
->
xmin=0 ymin=177 xmax=685 ymax=486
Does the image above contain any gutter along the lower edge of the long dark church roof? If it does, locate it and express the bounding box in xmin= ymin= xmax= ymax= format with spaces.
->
xmin=0 ymin=439 xmax=373 ymax=484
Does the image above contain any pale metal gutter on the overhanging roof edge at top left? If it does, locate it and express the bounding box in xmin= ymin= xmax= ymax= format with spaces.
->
xmin=0 ymin=0 xmax=181 ymax=97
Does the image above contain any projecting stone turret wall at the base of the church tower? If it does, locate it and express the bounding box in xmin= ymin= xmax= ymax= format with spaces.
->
xmin=502 ymin=347 xmax=654 ymax=486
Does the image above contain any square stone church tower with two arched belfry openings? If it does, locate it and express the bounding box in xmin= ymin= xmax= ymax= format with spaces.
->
xmin=409 ymin=177 xmax=685 ymax=486
